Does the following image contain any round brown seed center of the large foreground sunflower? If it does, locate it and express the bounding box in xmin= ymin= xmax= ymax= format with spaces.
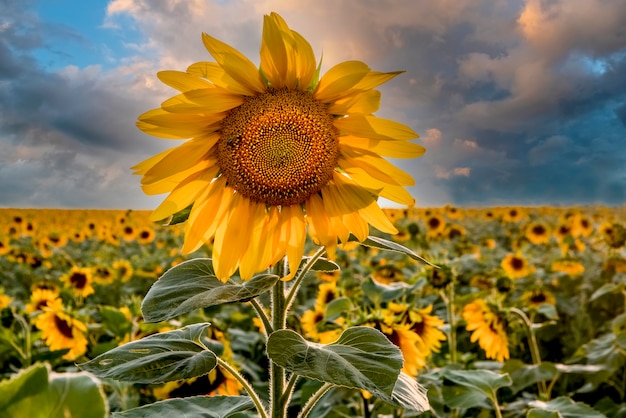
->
xmin=218 ymin=89 xmax=339 ymax=206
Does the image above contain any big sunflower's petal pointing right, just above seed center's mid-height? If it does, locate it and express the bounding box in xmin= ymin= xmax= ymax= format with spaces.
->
xmin=334 ymin=114 xmax=419 ymax=140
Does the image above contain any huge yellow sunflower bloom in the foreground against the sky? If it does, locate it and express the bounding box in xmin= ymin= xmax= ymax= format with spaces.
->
xmin=133 ymin=13 xmax=424 ymax=281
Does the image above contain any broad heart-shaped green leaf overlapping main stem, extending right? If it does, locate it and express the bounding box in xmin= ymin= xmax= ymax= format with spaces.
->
xmin=267 ymin=327 xmax=403 ymax=401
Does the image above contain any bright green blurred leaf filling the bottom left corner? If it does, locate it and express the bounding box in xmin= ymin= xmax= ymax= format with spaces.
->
xmin=0 ymin=364 xmax=109 ymax=418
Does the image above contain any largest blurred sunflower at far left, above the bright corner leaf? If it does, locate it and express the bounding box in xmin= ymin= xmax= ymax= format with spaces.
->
xmin=35 ymin=299 xmax=87 ymax=361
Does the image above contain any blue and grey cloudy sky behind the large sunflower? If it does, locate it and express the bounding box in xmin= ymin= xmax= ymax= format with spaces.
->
xmin=0 ymin=0 xmax=626 ymax=209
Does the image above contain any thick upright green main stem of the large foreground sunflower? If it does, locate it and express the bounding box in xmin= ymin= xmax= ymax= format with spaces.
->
xmin=269 ymin=260 xmax=288 ymax=418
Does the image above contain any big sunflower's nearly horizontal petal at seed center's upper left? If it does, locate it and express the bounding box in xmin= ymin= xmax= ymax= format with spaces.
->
xmin=161 ymin=87 xmax=243 ymax=114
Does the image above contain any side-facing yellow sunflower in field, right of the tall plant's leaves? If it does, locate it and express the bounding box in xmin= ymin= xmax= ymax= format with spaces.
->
xmin=463 ymin=299 xmax=509 ymax=362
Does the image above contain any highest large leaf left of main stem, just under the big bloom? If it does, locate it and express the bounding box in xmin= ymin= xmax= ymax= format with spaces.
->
xmin=141 ymin=258 xmax=278 ymax=322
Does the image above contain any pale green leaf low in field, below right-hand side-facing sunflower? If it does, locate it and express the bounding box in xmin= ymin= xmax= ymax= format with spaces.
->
xmin=442 ymin=369 xmax=513 ymax=408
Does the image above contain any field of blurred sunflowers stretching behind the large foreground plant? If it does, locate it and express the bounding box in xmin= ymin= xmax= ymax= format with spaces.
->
xmin=0 ymin=206 xmax=626 ymax=417
